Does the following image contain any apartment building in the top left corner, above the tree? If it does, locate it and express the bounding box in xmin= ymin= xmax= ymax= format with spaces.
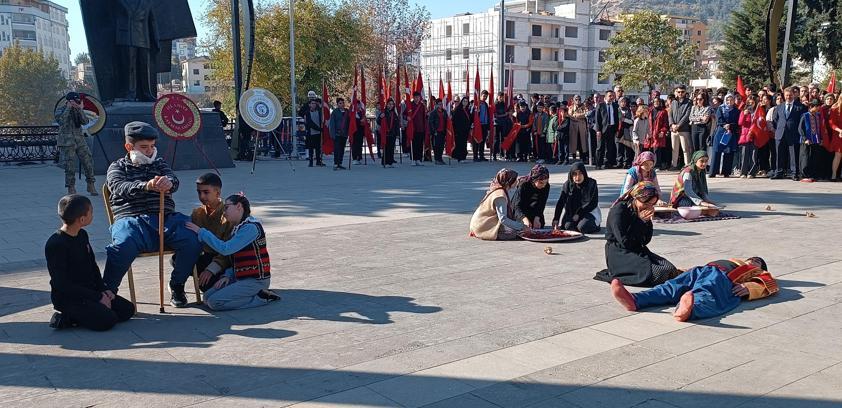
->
xmin=0 ymin=0 xmax=71 ymax=79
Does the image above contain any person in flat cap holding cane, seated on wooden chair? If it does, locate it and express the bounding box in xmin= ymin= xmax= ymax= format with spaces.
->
xmin=103 ymin=122 xmax=202 ymax=307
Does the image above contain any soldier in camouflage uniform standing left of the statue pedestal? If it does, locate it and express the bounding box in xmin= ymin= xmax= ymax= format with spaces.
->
xmin=56 ymin=92 xmax=97 ymax=195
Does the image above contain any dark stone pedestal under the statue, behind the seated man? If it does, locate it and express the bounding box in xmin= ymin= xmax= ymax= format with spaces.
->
xmin=88 ymin=102 xmax=234 ymax=175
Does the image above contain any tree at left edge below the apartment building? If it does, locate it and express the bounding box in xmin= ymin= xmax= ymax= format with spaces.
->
xmin=0 ymin=43 xmax=67 ymax=125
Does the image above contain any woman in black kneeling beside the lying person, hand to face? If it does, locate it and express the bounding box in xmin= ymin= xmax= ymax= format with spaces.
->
xmin=594 ymin=181 xmax=679 ymax=287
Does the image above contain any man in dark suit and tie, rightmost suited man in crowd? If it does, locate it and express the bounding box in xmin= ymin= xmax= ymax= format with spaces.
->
xmin=769 ymin=88 xmax=807 ymax=180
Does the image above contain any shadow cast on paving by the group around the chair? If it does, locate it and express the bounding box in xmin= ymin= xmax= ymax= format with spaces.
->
xmin=0 ymin=289 xmax=442 ymax=351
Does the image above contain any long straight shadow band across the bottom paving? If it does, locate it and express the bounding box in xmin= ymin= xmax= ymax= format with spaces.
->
xmin=0 ymin=353 xmax=839 ymax=408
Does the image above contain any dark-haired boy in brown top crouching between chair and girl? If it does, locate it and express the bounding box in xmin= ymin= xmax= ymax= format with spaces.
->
xmin=190 ymin=173 xmax=234 ymax=292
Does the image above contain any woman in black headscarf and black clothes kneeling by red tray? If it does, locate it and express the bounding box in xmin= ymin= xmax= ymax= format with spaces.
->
xmin=553 ymin=161 xmax=600 ymax=234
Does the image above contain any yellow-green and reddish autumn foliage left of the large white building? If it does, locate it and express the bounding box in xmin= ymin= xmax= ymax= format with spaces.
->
xmin=201 ymin=0 xmax=429 ymax=111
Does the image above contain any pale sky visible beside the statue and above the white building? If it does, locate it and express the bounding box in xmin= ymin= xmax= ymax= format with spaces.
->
xmin=67 ymin=0 xmax=498 ymax=60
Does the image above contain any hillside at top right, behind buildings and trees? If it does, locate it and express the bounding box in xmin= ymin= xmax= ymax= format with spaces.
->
xmin=608 ymin=0 xmax=741 ymax=42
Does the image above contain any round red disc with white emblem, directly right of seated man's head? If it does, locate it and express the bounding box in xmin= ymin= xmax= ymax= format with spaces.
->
xmin=154 ymin=94 xmax=202 ymax=139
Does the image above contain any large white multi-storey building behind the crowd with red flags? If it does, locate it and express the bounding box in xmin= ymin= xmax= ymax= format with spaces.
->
xmin=421 ymin=0 xmax=619 ymax=100
